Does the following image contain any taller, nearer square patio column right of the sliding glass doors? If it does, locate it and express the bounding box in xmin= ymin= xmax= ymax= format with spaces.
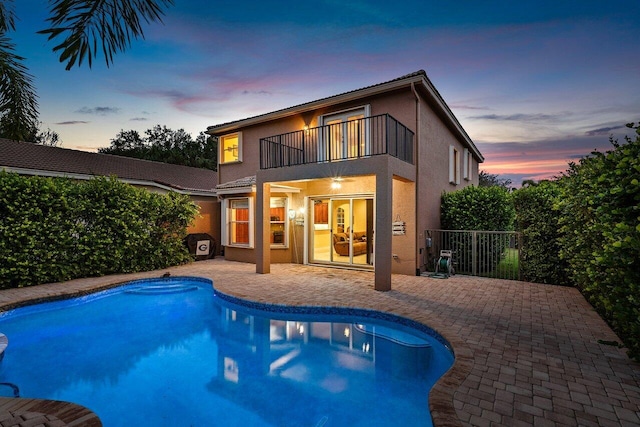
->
xmin=373 ymin=166 xmax=393 ymax=291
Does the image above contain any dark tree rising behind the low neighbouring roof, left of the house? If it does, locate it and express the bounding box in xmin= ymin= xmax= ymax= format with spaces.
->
xmin=98 ymin=125 xmax=218 ymax=170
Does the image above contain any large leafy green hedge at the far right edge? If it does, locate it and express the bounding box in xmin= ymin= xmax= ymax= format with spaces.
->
xmin=559 ymin=125 xmax=640 ymax=359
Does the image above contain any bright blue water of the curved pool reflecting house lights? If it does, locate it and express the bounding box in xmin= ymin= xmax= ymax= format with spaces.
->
xmin=0 ymin=278 xmax=453 ymax=427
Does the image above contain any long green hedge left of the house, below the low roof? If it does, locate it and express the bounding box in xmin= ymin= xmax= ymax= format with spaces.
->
xmin=0 ymin=172 xmax=197 ymax=288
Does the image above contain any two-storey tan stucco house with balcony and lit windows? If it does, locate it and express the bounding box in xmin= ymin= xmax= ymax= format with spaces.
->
xmin=207 ymin=71 xmax=484 ymax=291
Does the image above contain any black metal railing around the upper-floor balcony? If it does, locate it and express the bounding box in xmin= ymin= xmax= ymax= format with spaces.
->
xmin=260 ymin=114 xmax=414 ymax=169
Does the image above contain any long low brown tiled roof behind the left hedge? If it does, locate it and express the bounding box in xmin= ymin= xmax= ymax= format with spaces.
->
xmin=0 ymin=138 xmax=218 ymax=196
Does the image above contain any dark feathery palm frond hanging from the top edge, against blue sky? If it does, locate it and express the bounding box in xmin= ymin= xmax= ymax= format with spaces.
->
xmin=39 ymin=0 xmax=173 ymax=70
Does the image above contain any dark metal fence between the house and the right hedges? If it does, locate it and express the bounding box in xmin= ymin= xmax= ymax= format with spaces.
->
xmin=425 ymin=230 xmax=522 ymax=280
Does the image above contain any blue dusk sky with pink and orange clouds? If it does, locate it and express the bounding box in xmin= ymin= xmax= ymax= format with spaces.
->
xmin=10 ymin=0 xmax=640 ymax=185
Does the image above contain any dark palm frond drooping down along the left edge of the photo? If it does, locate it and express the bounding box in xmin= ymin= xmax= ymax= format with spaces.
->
xmin=0 ymin=32 xmax=38 ymax=140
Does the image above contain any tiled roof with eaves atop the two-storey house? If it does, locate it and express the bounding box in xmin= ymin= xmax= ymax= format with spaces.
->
xmin=207 ymin=70 xmax=484 ymax=162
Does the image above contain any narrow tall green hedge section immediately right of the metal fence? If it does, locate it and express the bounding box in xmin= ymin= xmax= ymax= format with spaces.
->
xmin=513 ymin=181 xmax=571 ymax=285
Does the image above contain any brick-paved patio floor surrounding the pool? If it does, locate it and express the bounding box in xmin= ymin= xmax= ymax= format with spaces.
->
xmin=0 ymin=259 xmax=640 ymax=427
